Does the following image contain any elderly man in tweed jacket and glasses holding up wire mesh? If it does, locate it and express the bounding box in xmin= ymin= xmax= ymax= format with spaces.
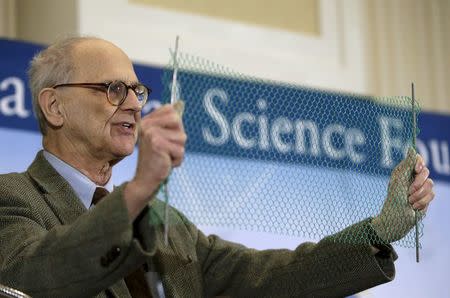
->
xmin=0 ymin=38 xmax=434 ymax=297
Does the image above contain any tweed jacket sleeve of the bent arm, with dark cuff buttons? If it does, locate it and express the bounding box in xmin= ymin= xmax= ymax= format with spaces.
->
xmin=0 ymin=178 xmax=154 ymax=297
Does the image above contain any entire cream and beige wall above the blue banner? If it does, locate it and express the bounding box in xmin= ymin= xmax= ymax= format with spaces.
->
xmin=0 ymin=0 xmax=450 ymax=113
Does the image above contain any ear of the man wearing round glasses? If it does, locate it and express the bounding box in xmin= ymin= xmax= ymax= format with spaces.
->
xmin=38 ymin=88 xmax=64 ymax=127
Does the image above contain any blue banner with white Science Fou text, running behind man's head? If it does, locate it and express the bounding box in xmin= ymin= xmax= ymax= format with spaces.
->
xmin=0 ymin=39 xmax=450 ymax=182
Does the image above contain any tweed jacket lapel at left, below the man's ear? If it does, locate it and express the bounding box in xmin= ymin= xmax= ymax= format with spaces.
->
xmin=27 ymin=150 xmax=86 ymax=224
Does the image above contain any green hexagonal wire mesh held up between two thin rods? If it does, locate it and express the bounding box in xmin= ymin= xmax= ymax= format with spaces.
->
xmin=158 ymin=53 xmax=423 ymax=247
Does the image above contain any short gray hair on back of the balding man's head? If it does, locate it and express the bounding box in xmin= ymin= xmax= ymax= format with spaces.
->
xmin=28 ymin=36 xmax=98 ymax=135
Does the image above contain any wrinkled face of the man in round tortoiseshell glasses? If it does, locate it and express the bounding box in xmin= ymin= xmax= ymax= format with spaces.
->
xmin=57 ymin=40 xmax=141 ymax=160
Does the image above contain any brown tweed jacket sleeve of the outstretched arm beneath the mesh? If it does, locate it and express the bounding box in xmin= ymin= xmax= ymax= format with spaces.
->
xmin=178 ymin=210 xmax=397 ymax=297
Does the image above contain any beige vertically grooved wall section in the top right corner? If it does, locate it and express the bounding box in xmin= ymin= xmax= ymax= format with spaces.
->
xmin=363 ymin=0 xmax=450 ymax=113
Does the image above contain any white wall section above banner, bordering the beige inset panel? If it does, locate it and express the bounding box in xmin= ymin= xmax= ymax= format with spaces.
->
xmin=79 ymin=0 xmax=367 ymax=93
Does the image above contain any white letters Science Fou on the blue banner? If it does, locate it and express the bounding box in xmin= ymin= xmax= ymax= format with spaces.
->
xmin=202 ymin=88 xmax=450 ymax=176
